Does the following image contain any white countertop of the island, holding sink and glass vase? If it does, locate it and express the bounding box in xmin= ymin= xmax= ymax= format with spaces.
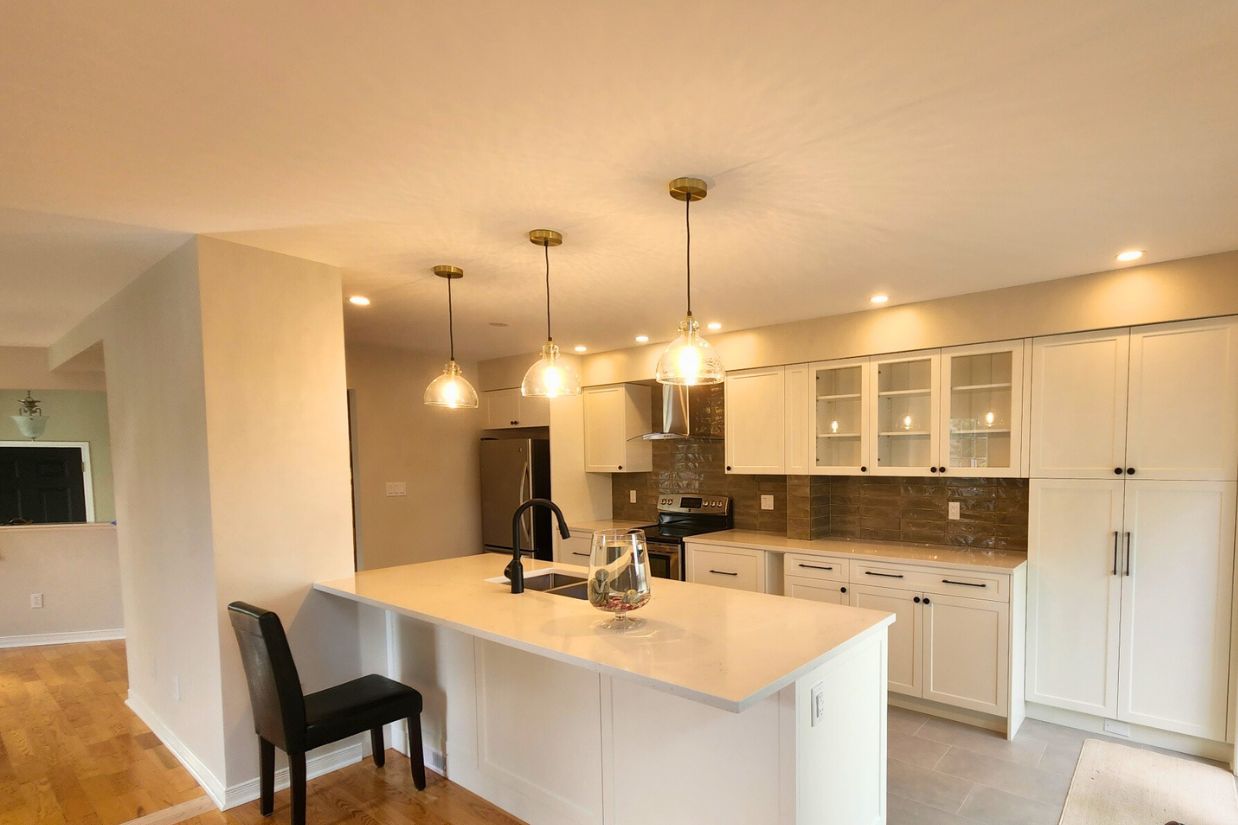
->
xmin=314 ymin=554 xmax=894 ymax=712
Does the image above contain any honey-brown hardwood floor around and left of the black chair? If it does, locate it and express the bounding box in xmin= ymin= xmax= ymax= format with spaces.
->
xmin=0 ymin=642 xmax=520 ymax=825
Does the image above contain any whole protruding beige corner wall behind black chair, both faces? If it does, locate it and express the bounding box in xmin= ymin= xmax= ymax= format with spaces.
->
xmin=52 ymin=238 xmax=360 ymax=798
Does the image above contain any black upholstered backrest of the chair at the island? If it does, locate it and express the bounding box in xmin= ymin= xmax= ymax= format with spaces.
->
xmin=228 ymin=602 xmax=306 ymax=752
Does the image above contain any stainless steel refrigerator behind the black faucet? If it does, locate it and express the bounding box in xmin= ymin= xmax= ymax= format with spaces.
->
xmin=482 ymin=439 xmax=555 ymax=561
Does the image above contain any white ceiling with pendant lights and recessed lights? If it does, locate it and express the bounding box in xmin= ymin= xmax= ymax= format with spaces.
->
xmin=0 ymin=0 xmax=1238 ymax=358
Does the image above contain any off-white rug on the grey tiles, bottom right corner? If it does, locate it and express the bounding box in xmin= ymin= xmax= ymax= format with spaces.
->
xmin=1058 ymin=740 xmax=1238 ymax=825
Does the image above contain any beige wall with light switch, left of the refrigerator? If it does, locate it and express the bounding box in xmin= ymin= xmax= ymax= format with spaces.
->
xmin=348 ymin=343 xmax=482 ymax=569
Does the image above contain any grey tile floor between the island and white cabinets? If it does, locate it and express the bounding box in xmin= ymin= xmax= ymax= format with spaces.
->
xmin=886 ymin=706 xmax=1228 ymax=825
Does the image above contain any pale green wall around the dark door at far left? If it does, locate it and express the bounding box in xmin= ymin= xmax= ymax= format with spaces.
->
xmin=0 ymin=386 xmax=116 ymax=522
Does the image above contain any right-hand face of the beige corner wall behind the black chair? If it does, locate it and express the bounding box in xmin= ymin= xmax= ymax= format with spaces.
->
xmin=198 ymin=238 xmax=361 ymax=787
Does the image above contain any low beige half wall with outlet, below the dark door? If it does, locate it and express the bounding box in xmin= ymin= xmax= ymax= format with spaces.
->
xmin=0 ymin=524 xmax=123 ymax=648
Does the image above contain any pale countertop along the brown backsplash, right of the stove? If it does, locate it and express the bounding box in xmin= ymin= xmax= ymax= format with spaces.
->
xmin=688 ymin=530 xmax=1028 ymax=572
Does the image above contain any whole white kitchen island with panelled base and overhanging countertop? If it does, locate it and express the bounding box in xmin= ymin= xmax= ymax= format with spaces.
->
xmin=314 ymin=554 xmax=894 ymax=825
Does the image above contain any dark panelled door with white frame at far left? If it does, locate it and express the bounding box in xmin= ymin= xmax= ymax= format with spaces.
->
xmin=0 ymin=447 xmax=85 ymax=524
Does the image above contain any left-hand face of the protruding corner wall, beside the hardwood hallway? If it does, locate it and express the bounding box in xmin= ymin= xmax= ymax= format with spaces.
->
xmin=79 ymin=240 xmax=224 ymax=782
